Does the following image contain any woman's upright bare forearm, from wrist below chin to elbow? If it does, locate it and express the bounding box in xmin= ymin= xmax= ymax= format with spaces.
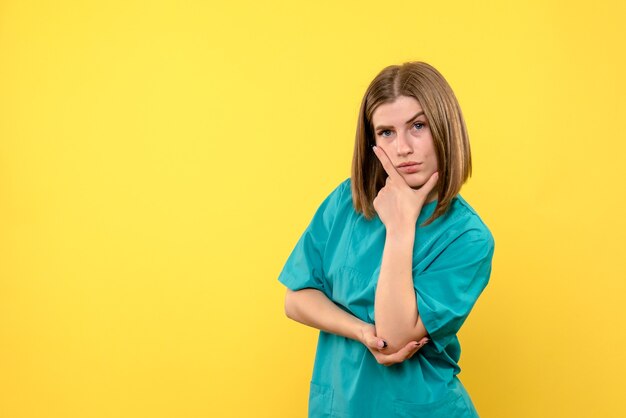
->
xmin=374 ymin=228 xmax=427 ymax=351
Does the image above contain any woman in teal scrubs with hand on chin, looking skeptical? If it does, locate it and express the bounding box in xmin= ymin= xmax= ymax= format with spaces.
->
xmin=278 ymin=62 xmax=494 ymax=418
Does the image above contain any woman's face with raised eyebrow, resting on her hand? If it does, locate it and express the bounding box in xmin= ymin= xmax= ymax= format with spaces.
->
xmin=372 ymin=96 xmax=438 ymax=202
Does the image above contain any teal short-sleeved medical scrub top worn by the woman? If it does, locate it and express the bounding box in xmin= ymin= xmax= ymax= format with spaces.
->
xmin=278 ymin=178 xmax=495 ymax=418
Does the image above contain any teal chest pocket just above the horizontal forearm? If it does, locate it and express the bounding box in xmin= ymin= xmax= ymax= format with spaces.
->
xmin=329 ymin=266 xmax=378 ymax=323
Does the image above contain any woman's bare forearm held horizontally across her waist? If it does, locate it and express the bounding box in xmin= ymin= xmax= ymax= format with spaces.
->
xmin=285 ymin=289 xmax=366 ymax=341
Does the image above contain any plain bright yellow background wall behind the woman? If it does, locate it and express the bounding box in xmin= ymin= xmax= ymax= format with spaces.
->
xmin=0 ymin=0 xmax=626 ymax=418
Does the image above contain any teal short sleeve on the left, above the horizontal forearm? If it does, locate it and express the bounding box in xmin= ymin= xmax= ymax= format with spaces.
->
xmin=278 ymin=180 xmax=347 ymax=297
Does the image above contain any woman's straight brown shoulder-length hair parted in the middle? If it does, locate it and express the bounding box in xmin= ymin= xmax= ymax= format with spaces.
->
xmin=351 ymin=61 xmax=472 ymax=226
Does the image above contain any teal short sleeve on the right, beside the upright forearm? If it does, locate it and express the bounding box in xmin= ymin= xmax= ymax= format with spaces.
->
xmin=414 ymin=230 xmax=495 ymax=351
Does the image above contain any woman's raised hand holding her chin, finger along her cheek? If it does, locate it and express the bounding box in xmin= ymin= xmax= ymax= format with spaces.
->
xmin=373 ymin=147 xmax=439 ymax=230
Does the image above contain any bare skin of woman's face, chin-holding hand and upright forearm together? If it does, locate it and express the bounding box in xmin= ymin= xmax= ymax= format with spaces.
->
xmin=372 ymin=96 xmax=438 ymax=351
